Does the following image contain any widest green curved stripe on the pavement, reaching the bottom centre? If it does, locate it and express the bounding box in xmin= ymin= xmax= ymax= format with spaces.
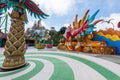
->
xmin=27 ymin=56 xmax=74 ymax=80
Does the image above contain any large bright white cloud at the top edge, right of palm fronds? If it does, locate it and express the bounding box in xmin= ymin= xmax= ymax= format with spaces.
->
xmin=33 ymin=0 xmax=76 ymax=16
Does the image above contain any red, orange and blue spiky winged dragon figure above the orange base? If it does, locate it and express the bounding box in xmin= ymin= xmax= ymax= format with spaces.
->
xmin=60 ymin=10 xmax=103 ymax=41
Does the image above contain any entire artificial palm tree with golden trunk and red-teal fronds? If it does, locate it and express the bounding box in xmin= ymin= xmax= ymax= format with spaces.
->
xmin=0 ymin=0 xmax=48 ymax=70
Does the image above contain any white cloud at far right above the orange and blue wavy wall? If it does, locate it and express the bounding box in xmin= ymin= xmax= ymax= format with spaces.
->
xmin=96 ymin=13 xmax=120 ymax=30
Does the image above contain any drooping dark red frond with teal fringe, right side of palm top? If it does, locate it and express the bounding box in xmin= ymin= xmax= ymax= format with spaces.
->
xmin=24 ymin=0 xmax=48 ymax=19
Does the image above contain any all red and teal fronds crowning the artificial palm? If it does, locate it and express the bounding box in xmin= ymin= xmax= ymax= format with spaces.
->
xmin=0 ymin=0 xmax=48 ymax=19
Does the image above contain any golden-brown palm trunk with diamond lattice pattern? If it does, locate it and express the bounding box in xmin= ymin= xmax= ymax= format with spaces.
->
xmin=2 ymin=4 xmax=26 ymax=69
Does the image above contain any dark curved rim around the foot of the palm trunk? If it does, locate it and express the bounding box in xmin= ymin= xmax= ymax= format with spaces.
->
xmin=0 ymin=63 xmax=29 ymax=72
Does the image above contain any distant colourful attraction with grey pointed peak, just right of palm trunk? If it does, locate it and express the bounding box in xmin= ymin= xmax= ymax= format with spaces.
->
xmin=25 ymin=20 xmax=52 ymax=49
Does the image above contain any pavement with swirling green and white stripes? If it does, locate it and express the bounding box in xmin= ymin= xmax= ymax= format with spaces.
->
xmin=0 ymin=47 xmax=120 ymax=80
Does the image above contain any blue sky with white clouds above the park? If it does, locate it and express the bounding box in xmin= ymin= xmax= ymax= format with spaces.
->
xmin=0 ymin=0 xmax=120 ymax=30
